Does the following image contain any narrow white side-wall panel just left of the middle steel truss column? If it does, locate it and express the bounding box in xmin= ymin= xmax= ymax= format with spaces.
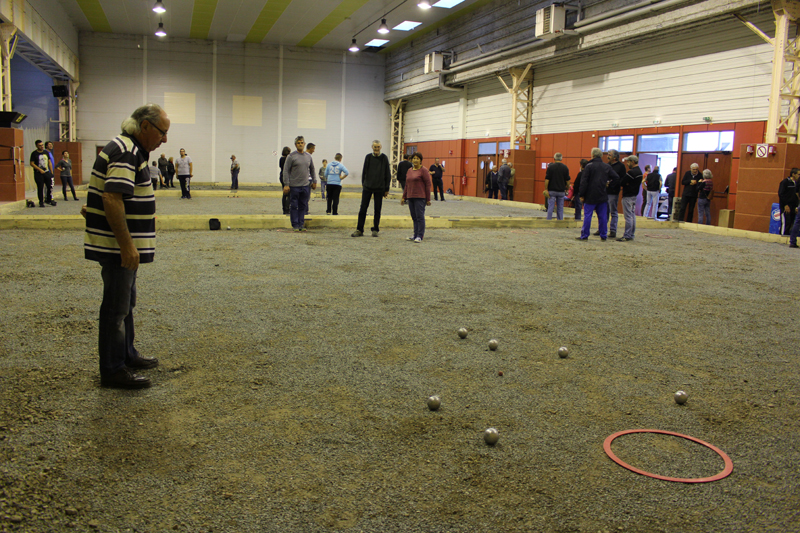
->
xmin=466 ymin=77 xmax=511 ymax=139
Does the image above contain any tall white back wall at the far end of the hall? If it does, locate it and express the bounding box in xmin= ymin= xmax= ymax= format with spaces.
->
xmin=78 ymin=33 xmax=389 ymax=183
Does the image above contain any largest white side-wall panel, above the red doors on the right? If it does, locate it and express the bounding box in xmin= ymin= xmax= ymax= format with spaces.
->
xmin=532 ymin=17 xmax=772 ymax=133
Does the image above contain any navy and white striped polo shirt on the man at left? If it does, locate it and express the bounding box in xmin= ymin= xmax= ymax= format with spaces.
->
xmin=83 ymin=133 xmax=156 ymax=264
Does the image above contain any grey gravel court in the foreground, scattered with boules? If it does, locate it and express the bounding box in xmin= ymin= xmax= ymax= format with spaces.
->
xmin=0 ymin=227 xmax=800 ymax=532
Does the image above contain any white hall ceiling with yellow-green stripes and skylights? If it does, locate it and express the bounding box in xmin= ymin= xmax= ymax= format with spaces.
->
xmin=58 ymin=0 xmax=492 ymax=50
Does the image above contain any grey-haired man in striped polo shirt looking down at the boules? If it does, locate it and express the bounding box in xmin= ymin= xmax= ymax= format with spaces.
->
xmin=84 ymin=104 xmax=170 ymax=389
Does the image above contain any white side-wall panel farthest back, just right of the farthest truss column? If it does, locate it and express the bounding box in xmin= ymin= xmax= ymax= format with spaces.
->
xmin=403 ymin=91 xmax=461 ymax=143
